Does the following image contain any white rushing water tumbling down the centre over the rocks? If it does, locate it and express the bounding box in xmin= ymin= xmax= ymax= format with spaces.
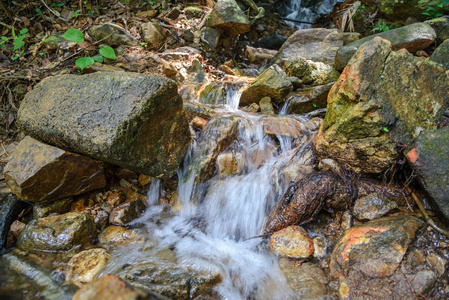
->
xmin=106 ymin=85 xmax=312 ymax=300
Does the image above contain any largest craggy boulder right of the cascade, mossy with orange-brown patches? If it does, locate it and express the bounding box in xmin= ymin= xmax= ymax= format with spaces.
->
xmin=315 ymin=37 xmax=449 ymax=173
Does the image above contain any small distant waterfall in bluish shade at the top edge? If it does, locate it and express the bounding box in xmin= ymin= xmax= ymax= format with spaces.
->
xmin=279 ymin=0 xmax=338 ymax=29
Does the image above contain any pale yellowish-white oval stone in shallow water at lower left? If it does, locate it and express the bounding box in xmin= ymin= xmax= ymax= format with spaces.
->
xmin=65 ymin=248 xmax=110 ymax=287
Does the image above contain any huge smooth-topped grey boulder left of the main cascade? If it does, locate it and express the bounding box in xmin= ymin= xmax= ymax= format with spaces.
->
xmin=18 ymin=72 xmax=190 ymax=177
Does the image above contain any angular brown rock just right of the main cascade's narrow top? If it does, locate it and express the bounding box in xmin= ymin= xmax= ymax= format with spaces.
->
xmin=240 ymin=66 xmax=293 ymax=106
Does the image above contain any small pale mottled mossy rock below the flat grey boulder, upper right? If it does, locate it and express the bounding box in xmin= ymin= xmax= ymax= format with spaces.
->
xmin=283 ymin=57 xmax=340 ymax=85
